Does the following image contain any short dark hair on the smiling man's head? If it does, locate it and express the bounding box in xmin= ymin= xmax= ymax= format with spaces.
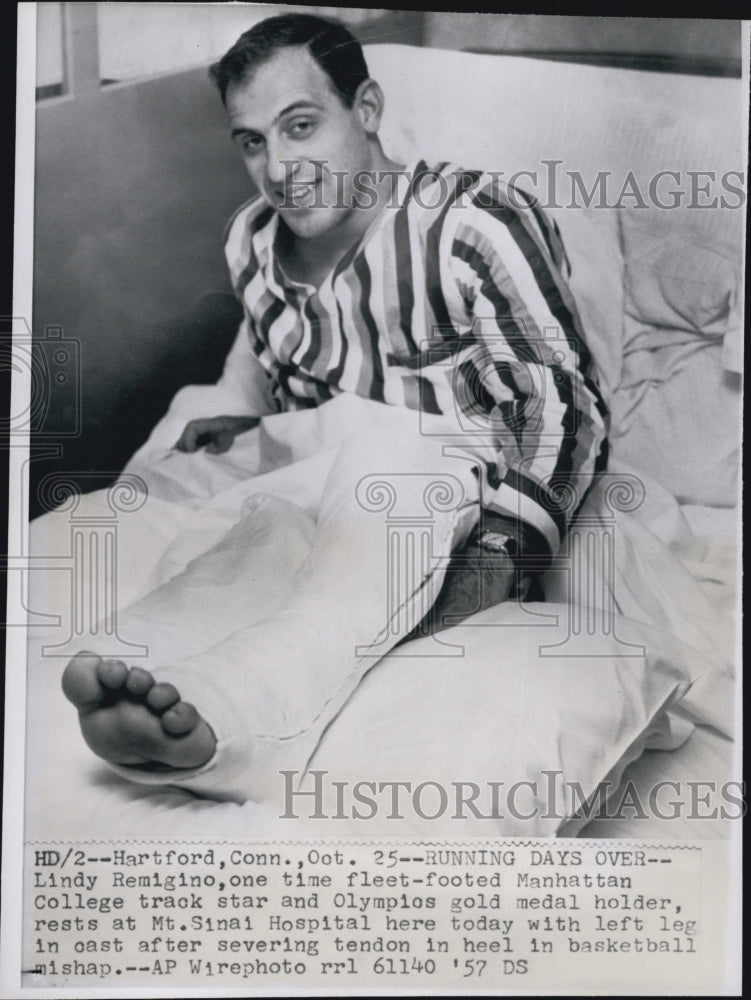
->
xmin=209 ymin=14 xmax=368 ymax=108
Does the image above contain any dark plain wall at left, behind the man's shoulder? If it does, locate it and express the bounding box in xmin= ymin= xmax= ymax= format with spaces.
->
xmin=30 ymin=3 xmax=422 ymax=514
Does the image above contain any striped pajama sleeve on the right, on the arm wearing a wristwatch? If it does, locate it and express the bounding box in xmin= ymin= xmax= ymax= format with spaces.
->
xmin=450 ymin=181 xmax=607 ymax=569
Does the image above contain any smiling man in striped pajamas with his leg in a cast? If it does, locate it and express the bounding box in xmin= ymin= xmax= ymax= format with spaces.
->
xmin=63 ymin=14 xmax=606 ymax=798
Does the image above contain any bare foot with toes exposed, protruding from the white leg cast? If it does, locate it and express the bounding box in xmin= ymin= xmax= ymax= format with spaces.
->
xmin=62 ymin=652 xmax=216 ymax=770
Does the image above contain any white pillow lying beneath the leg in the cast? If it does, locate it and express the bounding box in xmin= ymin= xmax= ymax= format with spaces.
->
xmin=306 ymin=604 xmax=702 ymax=837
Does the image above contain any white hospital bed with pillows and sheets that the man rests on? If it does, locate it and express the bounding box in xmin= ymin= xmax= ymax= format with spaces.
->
xmin=26 ymin=45 xmax=747 ymax=840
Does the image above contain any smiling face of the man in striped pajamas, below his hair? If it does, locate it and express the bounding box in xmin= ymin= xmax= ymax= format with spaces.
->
xmin=226 ymin=47 xmax=378 ymax=239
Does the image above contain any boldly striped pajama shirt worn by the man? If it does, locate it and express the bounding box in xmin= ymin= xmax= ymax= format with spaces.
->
xmin=225 ymin=161 xmax=607 ymax=568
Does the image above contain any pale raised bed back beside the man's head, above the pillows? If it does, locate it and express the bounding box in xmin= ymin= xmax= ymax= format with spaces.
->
xmin=367 ymin=45 xmax=746 ymax=248
